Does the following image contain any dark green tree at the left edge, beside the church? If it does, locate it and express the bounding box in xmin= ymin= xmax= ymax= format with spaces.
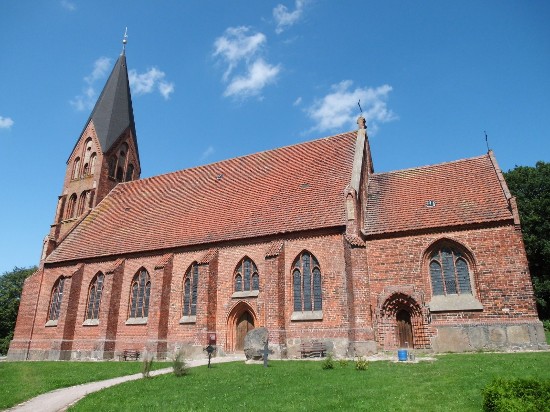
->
xmin=0 ymin=266 xmax=36 ymax=355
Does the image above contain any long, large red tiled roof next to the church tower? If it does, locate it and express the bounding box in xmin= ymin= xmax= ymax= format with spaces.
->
xmin=46 ymin=132 xmax=356 ymax=263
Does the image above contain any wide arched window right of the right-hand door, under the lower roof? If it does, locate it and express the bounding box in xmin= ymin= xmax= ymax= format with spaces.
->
xmin=430 ymin=247 xmax=472 ymax=295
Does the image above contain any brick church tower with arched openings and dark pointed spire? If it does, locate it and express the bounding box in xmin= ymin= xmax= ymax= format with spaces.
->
xmin=42 ymin=35 xmax=141 ymax=260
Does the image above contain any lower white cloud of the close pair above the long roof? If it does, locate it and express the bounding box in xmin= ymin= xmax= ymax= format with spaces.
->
xmin=224 ymin=59 xmax=281 ymax=98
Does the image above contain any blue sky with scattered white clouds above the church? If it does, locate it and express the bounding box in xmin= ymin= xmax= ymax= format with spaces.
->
xmin=0 ymin=0 xmax=550 ymax=273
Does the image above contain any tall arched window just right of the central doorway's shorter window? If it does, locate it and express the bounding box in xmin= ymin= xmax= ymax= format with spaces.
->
xmin=292 ymin=252 xmax=323 ymax=312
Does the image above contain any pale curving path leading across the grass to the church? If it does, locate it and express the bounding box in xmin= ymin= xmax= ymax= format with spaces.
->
xmin=8 ymin=355 xmax=245 ymax=412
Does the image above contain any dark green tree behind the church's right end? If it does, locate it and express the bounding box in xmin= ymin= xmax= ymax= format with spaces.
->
xmin=504 ymin=162 xmax=550 ymax=319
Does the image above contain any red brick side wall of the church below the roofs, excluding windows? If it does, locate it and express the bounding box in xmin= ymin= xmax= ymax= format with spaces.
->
xmin=10 ymin=225 xmax=537 ymax=359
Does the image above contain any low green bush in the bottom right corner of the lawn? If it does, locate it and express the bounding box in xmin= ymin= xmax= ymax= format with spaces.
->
xmin=482 ymin=378 xmax=550 ymax=412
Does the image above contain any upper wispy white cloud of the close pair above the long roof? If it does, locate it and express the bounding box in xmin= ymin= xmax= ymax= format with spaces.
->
xmin=213 ymin=26 xmax=266 ymax=80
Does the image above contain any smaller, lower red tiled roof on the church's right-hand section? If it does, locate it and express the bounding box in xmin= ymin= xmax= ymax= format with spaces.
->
xmin=365 ymin=155 xmax=513 ymax=235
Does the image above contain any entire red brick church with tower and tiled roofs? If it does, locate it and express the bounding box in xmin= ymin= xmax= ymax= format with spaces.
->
xmin=8 ymin=45 xmax=545 ymax=360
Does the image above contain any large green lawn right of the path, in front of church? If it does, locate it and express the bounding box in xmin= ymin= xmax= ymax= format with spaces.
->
xmin=71 ymin=352 xmax=550 ymax=411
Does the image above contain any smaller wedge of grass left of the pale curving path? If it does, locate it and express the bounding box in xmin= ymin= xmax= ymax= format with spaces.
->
xmin=0 ymin=362 xmax=170 ymax=409
